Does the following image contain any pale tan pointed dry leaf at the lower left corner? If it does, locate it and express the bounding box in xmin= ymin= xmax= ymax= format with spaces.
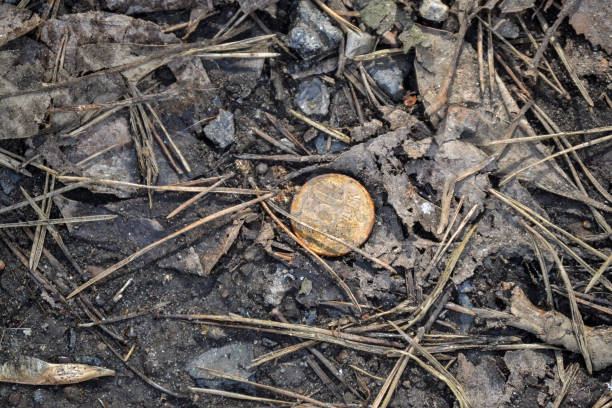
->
xmin=0 ymin=356 xmax=115 ymax=385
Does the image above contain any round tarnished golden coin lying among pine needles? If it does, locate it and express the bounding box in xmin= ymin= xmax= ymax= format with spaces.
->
xmin=291 ymin=173 xmax=374 ymax=256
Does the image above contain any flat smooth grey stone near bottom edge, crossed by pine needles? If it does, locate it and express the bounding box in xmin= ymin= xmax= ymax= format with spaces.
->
xmin=185 ymin=343 xmax=254 ymax=390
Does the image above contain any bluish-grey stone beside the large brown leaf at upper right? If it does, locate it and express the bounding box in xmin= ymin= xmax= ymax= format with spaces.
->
xmin=367 ymin=55 xmax=410 ymax=102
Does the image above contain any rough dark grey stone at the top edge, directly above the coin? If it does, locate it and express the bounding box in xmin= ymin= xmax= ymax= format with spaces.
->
xmin=288 ymin=0 xmax=342 ymax=60
